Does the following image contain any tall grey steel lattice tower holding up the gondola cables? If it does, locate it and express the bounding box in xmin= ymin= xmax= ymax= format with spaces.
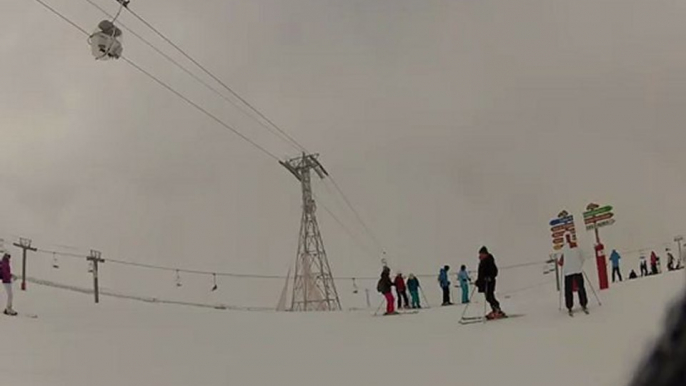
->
xmin=280 ymin=153 xmax=341 ymax=311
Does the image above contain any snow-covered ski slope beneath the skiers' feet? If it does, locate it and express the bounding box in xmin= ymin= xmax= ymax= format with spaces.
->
xmin=0 ymin=271 xmax=684 ymax=386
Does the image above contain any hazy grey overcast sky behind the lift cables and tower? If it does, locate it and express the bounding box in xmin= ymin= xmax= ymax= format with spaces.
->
xmin=0 ymin=0 xmax=686 ymax=304
